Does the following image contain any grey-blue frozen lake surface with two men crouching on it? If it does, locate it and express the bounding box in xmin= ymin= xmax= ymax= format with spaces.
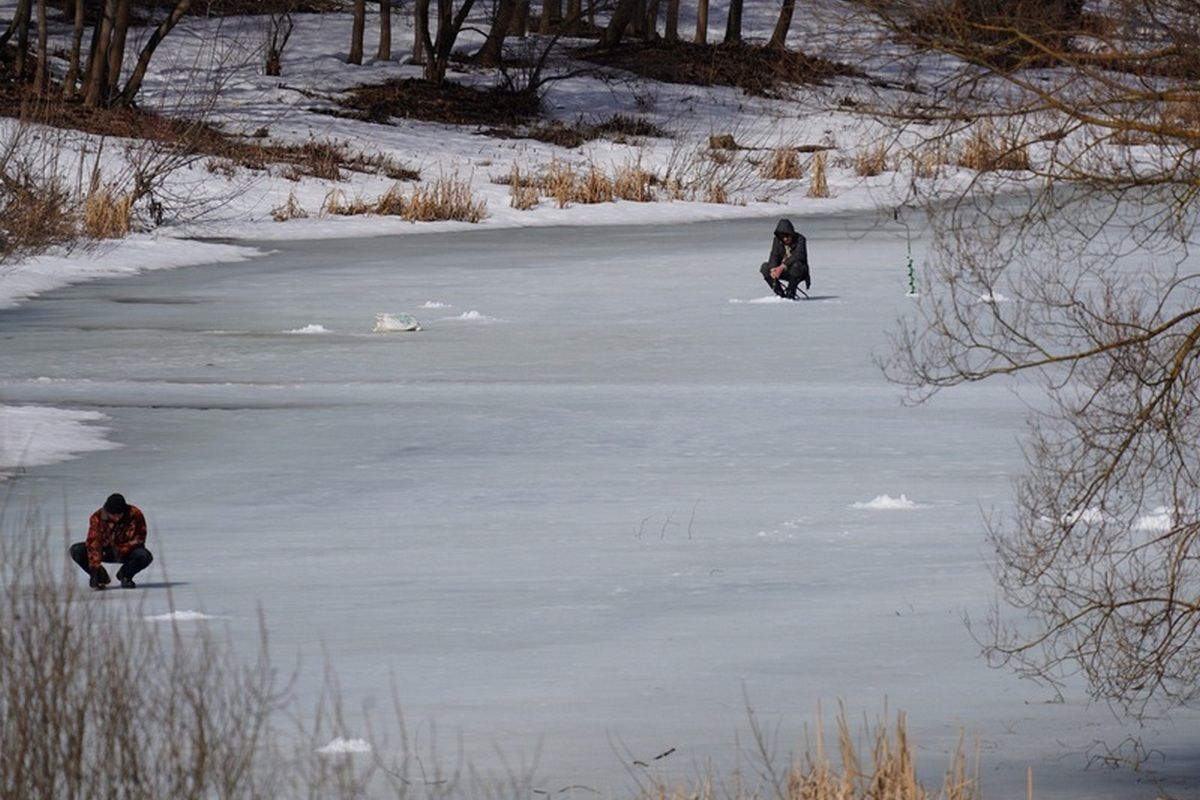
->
xmin=0 ymin=217 xmax=1200 ymax=799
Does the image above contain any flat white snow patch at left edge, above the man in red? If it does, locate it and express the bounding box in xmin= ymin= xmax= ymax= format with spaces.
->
xmin=0 ymin=407 xmax=121 ymax=481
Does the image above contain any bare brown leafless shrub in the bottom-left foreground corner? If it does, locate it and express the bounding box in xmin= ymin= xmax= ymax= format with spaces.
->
xmin=0 ymin=518 xmax=288 ymax=800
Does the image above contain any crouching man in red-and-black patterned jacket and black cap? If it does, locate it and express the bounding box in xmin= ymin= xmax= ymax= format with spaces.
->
xmin=71 ymin=494 xmax=154 ymax=589
